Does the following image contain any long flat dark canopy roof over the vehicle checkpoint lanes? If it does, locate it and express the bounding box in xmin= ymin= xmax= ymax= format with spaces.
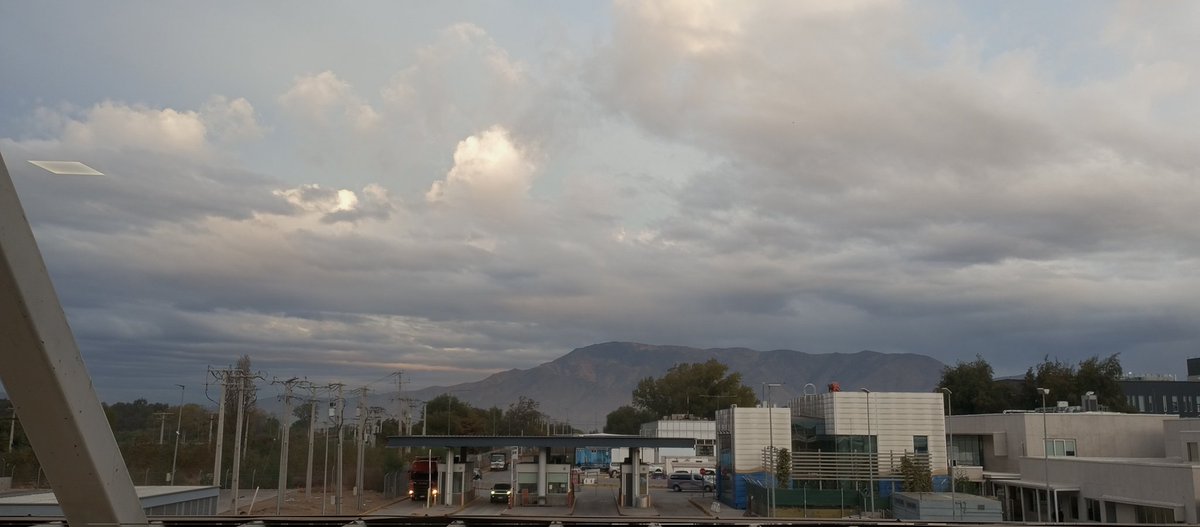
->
xmin=388 ymin=435 xmax=696 ymax=448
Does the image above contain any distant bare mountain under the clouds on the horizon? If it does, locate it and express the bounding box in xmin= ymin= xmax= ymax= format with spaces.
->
xmin=406 ymin=342 xmax=943 ymax=431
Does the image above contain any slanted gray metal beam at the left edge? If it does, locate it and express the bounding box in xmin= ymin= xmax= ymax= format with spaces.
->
xmin=0 ymin=156 xmax=146 ymax=527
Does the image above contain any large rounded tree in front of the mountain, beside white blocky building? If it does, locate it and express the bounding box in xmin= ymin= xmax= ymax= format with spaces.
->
xmin=632 ymin=359 xmax=758 ymax=419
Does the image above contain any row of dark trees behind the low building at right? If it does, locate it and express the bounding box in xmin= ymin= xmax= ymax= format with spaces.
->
xmin=937 ymin=354 xmax=1133 ymax=414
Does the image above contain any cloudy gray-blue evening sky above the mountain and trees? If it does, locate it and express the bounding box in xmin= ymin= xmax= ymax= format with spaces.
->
xmin=0 ymin=0 xmax=1200 ymax=402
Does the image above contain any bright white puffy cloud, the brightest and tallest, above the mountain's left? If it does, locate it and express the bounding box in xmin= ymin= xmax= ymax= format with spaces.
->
xmin=425 ymin=126 xmax=535 ymax=210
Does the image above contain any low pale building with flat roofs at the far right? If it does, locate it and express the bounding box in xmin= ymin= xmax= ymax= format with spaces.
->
xmin=948 ymin=412 xmax=1200 ymax=523
